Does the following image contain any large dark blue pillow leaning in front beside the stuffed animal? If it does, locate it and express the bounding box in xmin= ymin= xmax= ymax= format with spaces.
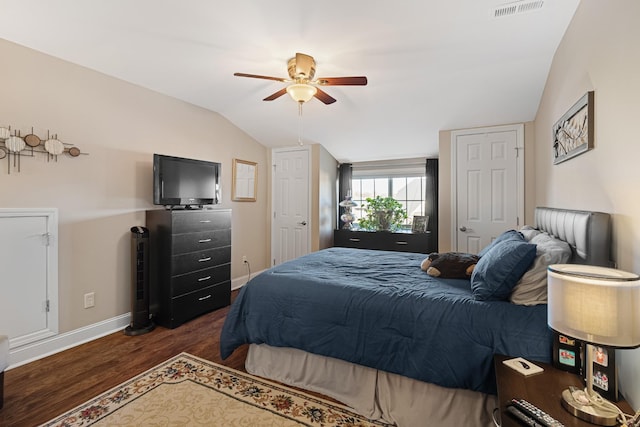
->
xmin=471 ymin=240 xmax=536 ymax=301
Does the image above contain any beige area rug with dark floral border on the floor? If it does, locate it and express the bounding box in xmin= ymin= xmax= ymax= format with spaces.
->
xmin=42 ymin=353 xmax=387 ymax=427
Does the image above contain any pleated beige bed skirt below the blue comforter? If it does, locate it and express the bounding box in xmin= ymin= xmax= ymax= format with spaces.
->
xmin=245 ymin=344 xmax=498 ymax=427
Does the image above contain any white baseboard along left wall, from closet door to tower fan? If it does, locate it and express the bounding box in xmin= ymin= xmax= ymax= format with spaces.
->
xmin=7 ymin=313 xmax=131 ymax=369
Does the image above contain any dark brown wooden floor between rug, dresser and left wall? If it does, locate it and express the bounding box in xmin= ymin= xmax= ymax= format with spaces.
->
xmin=0 ymin=292 xmax=247 ymax=427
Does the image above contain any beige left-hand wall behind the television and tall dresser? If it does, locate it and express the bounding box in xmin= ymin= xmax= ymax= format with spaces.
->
xmin=0 ymin=40 xmax=269 ymax=332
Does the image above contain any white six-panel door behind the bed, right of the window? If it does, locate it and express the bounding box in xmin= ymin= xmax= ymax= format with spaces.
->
xmin=452 ymin=125 xmax=524 ymax=253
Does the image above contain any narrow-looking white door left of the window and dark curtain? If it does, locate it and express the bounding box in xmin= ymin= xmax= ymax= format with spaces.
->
xmin=271 ymin=147 xmax=311 ymax=265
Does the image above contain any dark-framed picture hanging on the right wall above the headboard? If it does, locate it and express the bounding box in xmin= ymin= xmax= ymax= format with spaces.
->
xmin=553 ymin=91 xmax=594 ymax=165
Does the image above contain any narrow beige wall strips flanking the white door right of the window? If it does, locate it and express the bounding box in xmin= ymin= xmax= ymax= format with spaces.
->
xmin=438 ymin=122 xmax=535 ymax=252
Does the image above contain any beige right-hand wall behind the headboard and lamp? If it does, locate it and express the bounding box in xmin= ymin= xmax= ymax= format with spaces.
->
xmin=535 ymin=0 xmax=640 ymax=409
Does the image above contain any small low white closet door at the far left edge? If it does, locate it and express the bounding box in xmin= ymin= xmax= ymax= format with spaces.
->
xmin=0 ymin=209 xmax=58 ymax=348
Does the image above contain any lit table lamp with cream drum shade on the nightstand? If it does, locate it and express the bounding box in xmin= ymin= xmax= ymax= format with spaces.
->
xmin=547 ymin=264 xmax=640 ymax=426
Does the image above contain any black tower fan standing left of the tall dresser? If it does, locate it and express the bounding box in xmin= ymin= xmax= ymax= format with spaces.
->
xmin=124 ymin=226 xmax=155 ymax=335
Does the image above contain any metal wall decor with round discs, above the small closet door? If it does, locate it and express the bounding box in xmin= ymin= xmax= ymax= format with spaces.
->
xmin=0 ymin=126 xmax=87 ymax=174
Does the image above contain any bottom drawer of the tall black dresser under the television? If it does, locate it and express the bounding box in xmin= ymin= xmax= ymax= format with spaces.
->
xmin=167 ymin=282 xmax=231 ymax=328
